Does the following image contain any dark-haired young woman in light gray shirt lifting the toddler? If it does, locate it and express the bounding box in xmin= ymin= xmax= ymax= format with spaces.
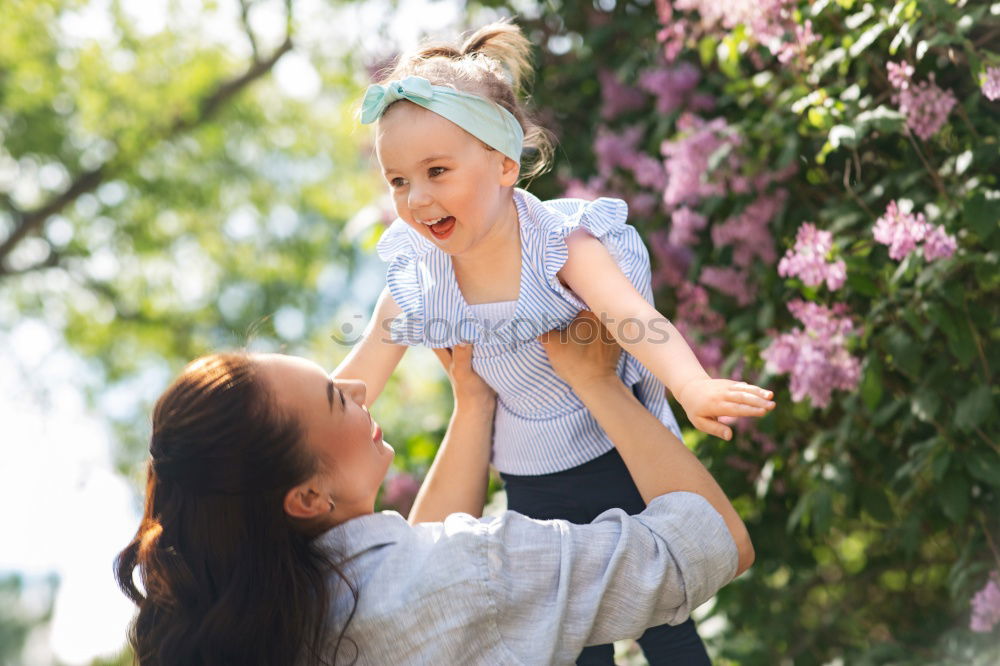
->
xmin=117 ymin=315 xmax=766 ymax=665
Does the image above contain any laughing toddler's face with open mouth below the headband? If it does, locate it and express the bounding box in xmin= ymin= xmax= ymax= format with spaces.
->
xmin=375 ymin=101 xmax=519 ymax=255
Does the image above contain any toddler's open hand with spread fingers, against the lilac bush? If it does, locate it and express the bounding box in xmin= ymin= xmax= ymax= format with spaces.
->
xmin=676 ymin=379 xmax=774 ymax=440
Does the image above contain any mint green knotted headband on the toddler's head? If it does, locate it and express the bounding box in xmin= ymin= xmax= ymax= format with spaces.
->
xmin=361 ymin=76 xmax=524 ymax=162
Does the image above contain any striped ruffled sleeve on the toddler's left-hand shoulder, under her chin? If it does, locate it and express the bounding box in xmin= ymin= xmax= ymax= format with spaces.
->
xmin=376 ymin=220 xmax=424 ymax=347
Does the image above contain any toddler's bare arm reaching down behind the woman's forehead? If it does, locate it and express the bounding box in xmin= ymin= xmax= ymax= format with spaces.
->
xmin=331 ymin=288 xmax=406 ymax=407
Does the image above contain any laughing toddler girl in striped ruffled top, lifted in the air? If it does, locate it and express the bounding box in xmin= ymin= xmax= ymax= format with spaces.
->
xmin=334 ymin=23 xmax=773 ymax=665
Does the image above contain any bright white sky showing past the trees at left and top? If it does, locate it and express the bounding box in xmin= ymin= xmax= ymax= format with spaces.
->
xmin=0 ymin=0 xmax=472 ymax=665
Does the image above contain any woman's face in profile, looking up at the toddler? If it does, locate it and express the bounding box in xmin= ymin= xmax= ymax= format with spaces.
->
xmin=256 ymin=354 xmax=394 ymax=513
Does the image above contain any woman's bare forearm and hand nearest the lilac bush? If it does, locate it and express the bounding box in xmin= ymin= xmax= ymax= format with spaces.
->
xmin=541 ymin=312 xmax=756 ymax=575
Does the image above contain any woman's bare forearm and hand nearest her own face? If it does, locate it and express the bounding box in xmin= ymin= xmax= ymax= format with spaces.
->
xmin=408 ymin=345 xmax=496 ymax=525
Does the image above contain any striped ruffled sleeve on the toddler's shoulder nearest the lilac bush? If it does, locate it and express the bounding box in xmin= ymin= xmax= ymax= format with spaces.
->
xmin=543 ymin=197 xmax=636 ymax=309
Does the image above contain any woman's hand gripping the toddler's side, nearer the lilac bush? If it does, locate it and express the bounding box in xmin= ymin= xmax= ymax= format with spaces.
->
xmin=538 ymin=310 xmax=622 ymax=390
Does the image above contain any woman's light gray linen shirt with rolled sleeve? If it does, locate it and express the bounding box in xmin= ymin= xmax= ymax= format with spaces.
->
xmin=319 ymin=492 xmax=738 ymax=666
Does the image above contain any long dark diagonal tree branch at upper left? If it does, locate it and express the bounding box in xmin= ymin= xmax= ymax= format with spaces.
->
xmin=0 ymin=34 xmax=292 ymax=277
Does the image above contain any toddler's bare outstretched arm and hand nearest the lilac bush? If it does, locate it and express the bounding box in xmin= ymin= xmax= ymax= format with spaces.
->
xmin=559 ymin=230 xmax=774 ymax=439
